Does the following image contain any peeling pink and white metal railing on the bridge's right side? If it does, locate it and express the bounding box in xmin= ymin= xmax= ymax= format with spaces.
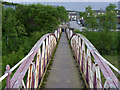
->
xmin=66 ymin=29 xmax=120 ymax=89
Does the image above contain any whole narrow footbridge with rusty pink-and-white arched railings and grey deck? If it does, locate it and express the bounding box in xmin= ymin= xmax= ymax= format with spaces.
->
xmin=0 ymin=28 xmax=120 ymax=89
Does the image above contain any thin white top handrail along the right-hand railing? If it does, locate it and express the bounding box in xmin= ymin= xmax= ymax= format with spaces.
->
xmin=71 ymin=33 xmax=120 ymax=74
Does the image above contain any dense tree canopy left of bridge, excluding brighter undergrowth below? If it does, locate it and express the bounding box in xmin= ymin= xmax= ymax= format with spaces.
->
xmin=2 ymin=4 xmax=68 ymax=55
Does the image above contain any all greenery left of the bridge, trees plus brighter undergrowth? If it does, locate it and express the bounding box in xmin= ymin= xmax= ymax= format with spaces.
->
xmin=2 ymin=1 xmax=68 ymax=87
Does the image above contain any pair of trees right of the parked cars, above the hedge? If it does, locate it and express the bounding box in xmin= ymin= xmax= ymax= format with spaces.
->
xmin=80 ymin=4 xmax=117 ymax=31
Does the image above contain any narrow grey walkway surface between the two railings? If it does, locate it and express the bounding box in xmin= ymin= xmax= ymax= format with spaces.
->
xmin=45 ymin=32 xmax=84 ymax=88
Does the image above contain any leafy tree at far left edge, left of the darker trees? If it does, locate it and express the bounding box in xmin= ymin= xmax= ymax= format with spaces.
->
xmin=2 ymin=8 xmax=26 ymax=54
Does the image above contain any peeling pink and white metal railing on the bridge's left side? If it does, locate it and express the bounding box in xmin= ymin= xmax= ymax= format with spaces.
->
xmin=0 ymin=28 xmax=61 ymax=88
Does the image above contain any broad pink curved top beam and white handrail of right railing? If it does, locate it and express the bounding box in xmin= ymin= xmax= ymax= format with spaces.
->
xmin=69 ymin=31 xmax=120 ymax=88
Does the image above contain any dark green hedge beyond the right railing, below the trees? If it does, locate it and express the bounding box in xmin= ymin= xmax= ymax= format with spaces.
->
xmin=74 ymin=31 xmax=120 ymax=55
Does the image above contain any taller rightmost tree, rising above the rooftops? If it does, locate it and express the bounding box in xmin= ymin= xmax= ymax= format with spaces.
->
xmin=97 ymin=4 xmax=117 ymax=31
